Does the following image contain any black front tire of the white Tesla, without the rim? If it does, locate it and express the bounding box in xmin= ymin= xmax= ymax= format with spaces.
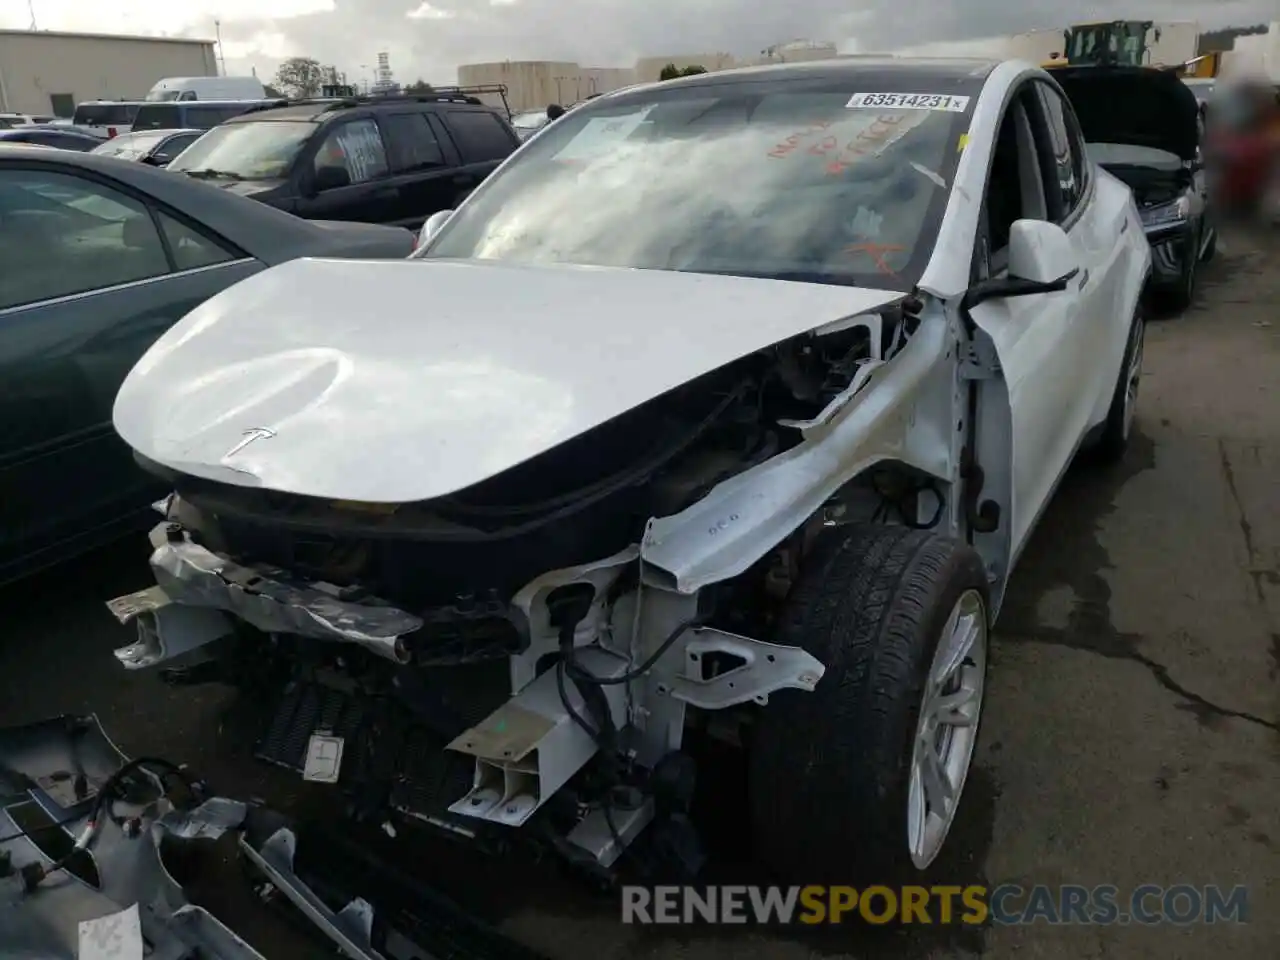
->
xmin=749 ymin=525 xmax=989 ymax=883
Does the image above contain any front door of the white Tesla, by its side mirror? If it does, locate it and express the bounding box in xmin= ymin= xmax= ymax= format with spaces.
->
xmin=970 ymin=83 xmax=1089 ymax=557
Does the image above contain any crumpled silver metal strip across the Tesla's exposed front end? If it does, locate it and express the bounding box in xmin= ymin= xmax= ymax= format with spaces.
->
xmin=133 ymin=524 xmax=422 ymax=663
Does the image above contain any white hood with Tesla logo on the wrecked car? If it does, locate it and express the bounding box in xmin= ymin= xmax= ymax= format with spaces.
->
xmin=114 ymin=259 xmax=904 ymax=503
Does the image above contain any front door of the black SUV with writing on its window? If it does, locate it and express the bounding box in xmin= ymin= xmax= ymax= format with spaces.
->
xmin=297 ymin=116 xmax=401 ymax=224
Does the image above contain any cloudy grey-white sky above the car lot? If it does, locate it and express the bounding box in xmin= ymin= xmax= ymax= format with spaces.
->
xmin=0 ymin=0 xmax=1280 ymax=83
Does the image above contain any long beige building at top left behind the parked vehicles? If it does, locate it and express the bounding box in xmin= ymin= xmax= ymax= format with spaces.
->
xmin=0 ymin=29 xmax=218 ymax=116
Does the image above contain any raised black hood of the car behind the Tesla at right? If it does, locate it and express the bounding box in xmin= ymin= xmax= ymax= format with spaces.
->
xmin=1052 ymin=67 xmax=1199 ymax=160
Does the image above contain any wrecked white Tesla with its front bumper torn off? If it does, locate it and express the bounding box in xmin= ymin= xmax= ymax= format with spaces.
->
xmin=110 ymin=58 xmax=1151 ymax=882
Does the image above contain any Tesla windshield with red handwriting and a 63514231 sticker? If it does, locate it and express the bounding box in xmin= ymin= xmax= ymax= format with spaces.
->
xmin=426 ymin=81 xmax=969 ymax=289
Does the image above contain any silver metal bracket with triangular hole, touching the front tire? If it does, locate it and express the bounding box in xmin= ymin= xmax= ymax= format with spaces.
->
xmin=664 ymin=627 xmax=827 ymax=710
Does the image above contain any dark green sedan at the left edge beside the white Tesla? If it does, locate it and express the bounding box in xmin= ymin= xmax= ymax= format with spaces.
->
xmin=0 ymin=146 xmax=415 ymax=581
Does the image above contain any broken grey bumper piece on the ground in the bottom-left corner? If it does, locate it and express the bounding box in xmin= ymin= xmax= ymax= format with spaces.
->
xmin=0 ymin=717 xmax=264 ymax=960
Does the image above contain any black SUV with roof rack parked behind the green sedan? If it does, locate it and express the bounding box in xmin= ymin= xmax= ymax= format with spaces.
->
xmin=168 ymin=91 xmax=520 ymax=229
